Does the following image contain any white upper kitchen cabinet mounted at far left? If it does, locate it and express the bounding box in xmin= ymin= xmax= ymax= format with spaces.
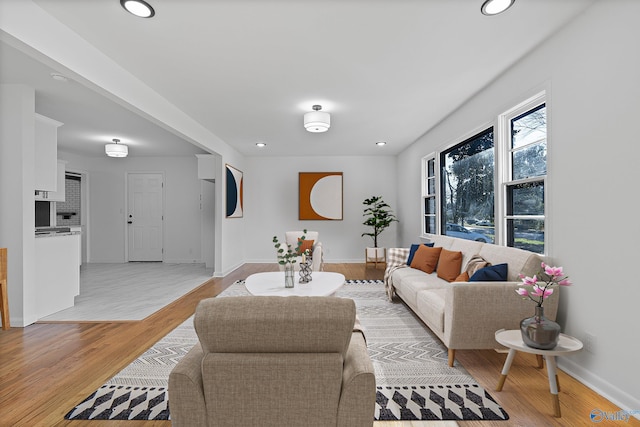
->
xmin=33 ymin=114 xmax=62 ymax=198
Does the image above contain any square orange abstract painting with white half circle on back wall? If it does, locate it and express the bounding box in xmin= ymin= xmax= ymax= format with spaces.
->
xmin=298 ymin=172 xmax=342 ymax=220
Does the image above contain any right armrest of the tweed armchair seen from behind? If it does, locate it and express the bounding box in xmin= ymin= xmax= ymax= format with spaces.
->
xmin=338 ymin=331 xmax=376 ymax=427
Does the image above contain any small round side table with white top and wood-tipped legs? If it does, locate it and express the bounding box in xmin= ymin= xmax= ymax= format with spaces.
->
xmin=496 ymin=329 xmax=582 ymax=418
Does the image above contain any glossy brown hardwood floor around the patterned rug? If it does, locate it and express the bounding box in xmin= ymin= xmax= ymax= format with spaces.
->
xmin=0 ymin=264 xmax=640 ymax=427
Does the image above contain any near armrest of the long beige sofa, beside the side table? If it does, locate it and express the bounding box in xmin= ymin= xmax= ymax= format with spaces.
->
xmin=443 ymin=282 xmax=560 ymax=349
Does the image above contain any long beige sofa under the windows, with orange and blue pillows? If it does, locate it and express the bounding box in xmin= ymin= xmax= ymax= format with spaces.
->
xmin=385 ymin=235 xmax=560 ymax=366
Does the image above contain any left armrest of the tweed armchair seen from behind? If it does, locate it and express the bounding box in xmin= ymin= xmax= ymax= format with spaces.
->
xmin=168 ymin=343 xmax=208 ymax=427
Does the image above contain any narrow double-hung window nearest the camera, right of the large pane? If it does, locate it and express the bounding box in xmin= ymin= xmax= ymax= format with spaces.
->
xmin=502 ymin=103 xmax=547 ymax=254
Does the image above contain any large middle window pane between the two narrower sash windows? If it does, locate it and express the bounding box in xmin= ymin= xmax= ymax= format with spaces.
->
xmin=440 ymin=127 xmax=495 ymax=242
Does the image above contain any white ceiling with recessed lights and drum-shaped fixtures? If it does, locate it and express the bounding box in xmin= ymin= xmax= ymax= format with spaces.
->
xmin=0 ymin=0 xmax=594 ymax=156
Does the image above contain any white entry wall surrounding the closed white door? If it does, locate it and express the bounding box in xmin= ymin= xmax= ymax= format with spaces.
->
xmin=58 ymin=152 xmax=203 ymax=263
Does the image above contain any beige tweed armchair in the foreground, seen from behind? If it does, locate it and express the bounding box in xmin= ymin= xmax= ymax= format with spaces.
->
xmin=169 ymin=296 xmax=376 ymax=427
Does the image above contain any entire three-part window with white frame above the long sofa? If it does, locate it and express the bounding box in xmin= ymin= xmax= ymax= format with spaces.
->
xmin=422 ymin=93 xmax=547 ymax=254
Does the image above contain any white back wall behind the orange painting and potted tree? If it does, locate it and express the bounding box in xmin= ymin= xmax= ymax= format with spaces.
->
xmin=244 ymin=156 xmax=397 ymax=262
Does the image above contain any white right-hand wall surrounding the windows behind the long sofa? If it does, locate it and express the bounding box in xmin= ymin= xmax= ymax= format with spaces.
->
xmin=398 ymin=0 xmax=640 ymax=416
